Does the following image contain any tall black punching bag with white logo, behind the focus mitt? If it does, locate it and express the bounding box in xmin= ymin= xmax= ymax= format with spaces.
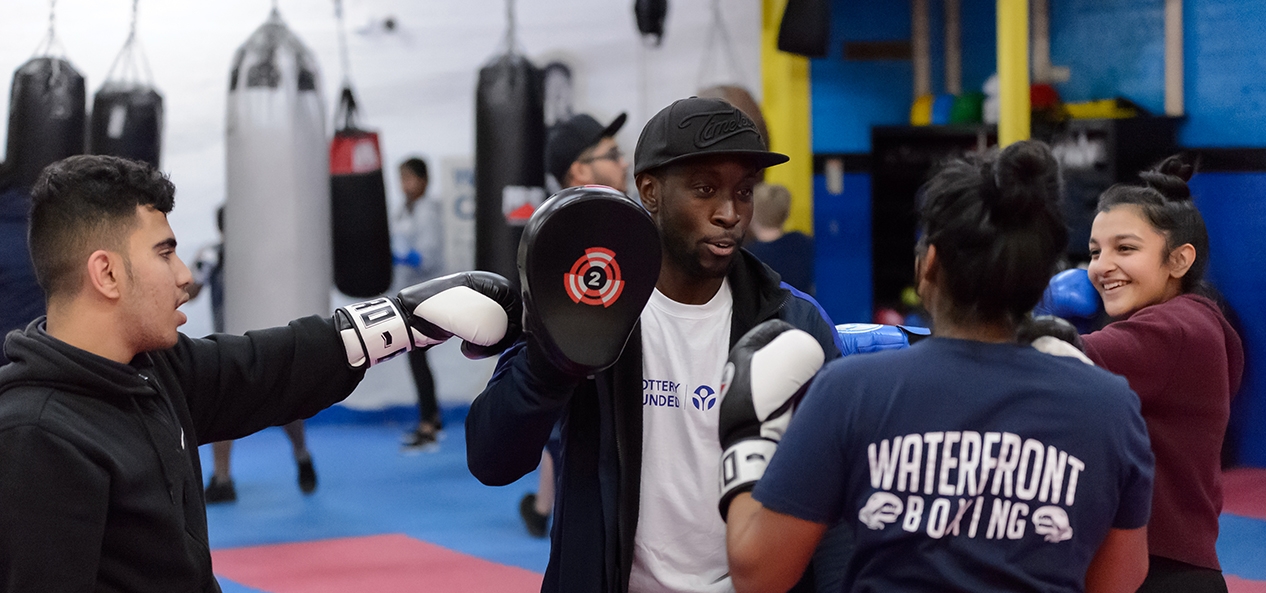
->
xmin=475 ymin=52 xmax=546 ymax=284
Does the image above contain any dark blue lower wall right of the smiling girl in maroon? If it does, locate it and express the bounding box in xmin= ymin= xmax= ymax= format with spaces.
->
xmin=1191 ymin=172 xmax=1266 ymax=468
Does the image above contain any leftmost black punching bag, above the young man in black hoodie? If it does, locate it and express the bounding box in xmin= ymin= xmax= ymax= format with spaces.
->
xmin=5 ymin=57 xmax=85 ymax=188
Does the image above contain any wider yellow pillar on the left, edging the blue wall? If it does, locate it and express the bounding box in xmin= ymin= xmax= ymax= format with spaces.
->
xmin=761 ymin=0 xmax=813 ymax=234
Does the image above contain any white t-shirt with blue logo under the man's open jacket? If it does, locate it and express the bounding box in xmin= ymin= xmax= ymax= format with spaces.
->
xmin=629 ymin=283 xmax=734 ymax=593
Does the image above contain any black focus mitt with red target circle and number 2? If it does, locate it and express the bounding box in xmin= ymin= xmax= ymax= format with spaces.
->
xmin=519 ymin=185 xmax=661 ymax=376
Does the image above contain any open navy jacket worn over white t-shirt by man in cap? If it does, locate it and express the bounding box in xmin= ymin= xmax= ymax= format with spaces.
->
xmin=466 ymin=250 xmax=839 ymax=593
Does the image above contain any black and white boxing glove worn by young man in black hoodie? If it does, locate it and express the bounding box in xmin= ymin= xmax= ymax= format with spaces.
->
xmin=334 ymin=271 xmax=523 ymax=369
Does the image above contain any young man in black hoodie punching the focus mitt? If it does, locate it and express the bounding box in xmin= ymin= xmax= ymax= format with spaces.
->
xmin=0 ymin=156 xmax=517 ymax=593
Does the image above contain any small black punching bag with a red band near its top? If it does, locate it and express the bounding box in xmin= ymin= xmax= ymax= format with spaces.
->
xmin=329 ymin=86 xmax=391 ymax=299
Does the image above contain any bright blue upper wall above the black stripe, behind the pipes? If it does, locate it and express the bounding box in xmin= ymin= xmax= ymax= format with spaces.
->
xmin=810 ymin=0 xmax=1266 ymax=153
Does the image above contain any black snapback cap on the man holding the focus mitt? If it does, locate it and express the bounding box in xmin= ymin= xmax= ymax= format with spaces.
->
xmin=633 ymin=96 xmax=790 ymax=175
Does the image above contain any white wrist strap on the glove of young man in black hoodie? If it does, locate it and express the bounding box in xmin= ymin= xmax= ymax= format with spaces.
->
xmin=334 ymin=297 xmax=413 ymax=369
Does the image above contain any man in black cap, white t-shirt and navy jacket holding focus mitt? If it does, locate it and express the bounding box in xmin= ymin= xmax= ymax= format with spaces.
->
xmin=466 ymin=98 xmax=839 ymax=593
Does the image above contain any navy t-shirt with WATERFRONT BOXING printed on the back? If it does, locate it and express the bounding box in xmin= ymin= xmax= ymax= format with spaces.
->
xmin=752 ymin=338 xmax=1153 ymax=592
